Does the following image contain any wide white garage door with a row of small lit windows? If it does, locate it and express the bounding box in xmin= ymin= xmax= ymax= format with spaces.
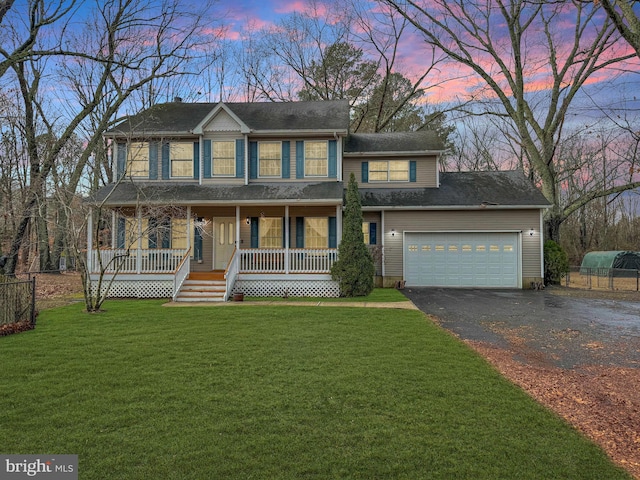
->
xmin=404 ymin=233 xmax=520 ymax=287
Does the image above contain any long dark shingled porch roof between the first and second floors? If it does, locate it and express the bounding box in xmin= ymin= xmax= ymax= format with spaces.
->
xmin=87 ymin=182 xmax=344 ymax=207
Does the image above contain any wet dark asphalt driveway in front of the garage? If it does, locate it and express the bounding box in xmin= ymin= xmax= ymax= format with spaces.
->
xmin=403 ymin=287 xmax=640 ymax=368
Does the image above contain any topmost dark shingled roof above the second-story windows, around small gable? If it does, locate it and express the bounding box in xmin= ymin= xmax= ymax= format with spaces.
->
xmin=105 ymin=100 xmax=349 ymax=137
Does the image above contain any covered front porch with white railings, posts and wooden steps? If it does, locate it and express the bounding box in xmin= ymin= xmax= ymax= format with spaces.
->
xmin=87 ymin=205 xmax=341 ymax=301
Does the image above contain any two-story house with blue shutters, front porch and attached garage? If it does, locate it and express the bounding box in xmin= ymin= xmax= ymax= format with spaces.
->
xmin=88 ymin=101 xmax=548 ymax=301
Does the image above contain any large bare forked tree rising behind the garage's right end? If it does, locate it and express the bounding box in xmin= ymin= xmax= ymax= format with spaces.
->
xmin=383 ymin=0 xmax=640 ymax=240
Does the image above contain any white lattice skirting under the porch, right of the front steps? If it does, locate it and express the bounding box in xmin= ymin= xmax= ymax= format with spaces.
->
xmin=231 ymin=280 xmax=340 ymax=298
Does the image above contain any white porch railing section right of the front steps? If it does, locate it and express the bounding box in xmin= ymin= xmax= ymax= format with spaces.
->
xmin=238 ymin=248 xmax=338 ymax=273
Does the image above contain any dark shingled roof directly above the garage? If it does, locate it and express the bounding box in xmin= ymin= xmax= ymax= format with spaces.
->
xmin=360 ymin=170 xmax=550 ymax=209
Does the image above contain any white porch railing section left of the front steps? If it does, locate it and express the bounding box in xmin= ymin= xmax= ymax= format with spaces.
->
xmin=90 ymin=248 xmax=187 ymax=273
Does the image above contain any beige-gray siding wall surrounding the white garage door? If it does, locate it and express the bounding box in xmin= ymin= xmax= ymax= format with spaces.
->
xmin=384 ymin=210 xmax=542 ymax=278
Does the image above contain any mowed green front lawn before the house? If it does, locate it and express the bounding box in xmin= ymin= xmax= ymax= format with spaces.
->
xmin=0 ymin=301 xmax=630 ymax=480
